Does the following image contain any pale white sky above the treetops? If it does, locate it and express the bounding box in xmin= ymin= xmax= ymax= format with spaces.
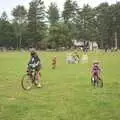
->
xmin=0 ymin=0 xmax=120 ymax=18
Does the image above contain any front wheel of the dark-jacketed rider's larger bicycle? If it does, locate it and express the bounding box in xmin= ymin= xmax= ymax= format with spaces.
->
xmin=21 ymin=74 xmax=33 ymax=90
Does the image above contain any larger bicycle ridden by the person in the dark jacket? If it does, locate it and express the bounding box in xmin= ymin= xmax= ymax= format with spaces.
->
xmin=21 ymin=69 xmax=37 ymax=90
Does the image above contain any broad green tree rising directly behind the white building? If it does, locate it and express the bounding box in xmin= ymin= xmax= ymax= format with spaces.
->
xmin=74 ymin=5 xmax=96 ymax=41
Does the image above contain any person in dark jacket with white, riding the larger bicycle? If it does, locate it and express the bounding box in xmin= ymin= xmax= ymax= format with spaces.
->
xmin=28 ymin=50 xmax=41 ymax=87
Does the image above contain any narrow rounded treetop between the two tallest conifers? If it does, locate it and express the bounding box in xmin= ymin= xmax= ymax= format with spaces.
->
xmin=47 ymin=3 xmax=59 ymax=25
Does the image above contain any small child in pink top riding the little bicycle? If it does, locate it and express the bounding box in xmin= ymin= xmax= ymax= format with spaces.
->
xmin=91 ymin=61 xmax=101 ymax=80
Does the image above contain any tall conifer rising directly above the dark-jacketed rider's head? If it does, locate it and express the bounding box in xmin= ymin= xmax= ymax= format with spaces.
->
xmin=28 ymin=0 xmax=46 ymax=45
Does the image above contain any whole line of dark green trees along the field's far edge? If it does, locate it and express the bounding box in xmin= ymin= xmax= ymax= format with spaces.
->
xmin=0 ymin=0 xmax=120 ymax=49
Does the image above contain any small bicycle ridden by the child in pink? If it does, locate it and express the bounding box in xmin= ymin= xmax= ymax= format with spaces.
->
xmin=91 ymin=75 xmax=103 ymax=88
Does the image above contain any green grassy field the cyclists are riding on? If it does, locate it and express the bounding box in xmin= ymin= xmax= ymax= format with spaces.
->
xmin=0 ymin=52 xmax=120 ymax=120
